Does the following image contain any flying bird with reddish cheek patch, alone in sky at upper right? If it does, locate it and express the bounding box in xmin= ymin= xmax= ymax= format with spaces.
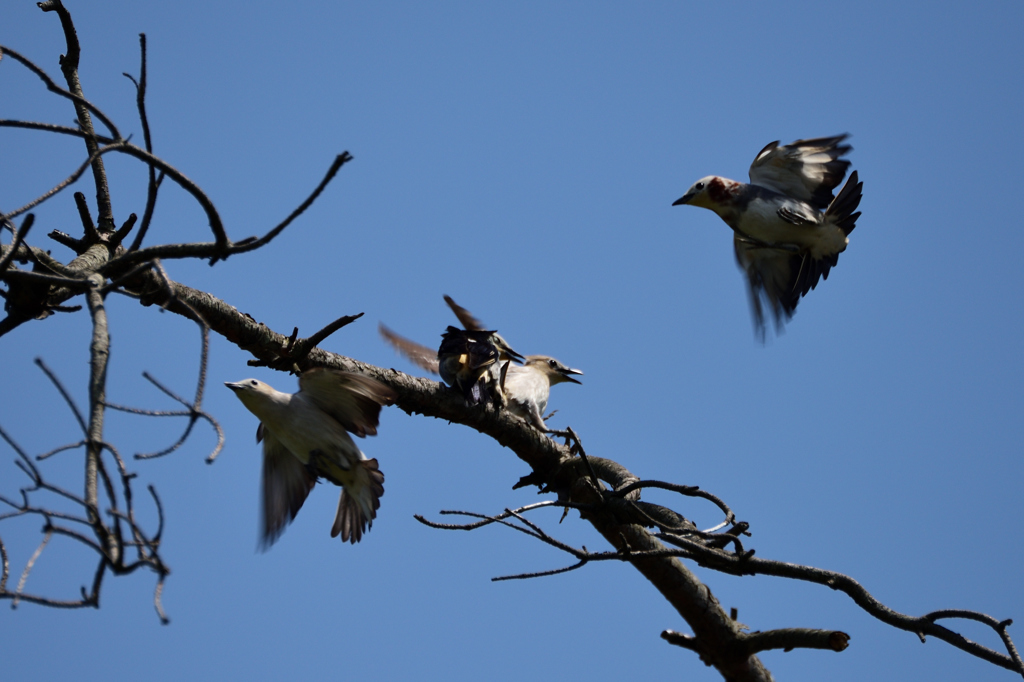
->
xmin=673 ymin=134 xmax=863 ymax=341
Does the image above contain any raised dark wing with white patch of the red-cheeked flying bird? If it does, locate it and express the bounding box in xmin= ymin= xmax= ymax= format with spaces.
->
xmin=751 ymin=135 xmax=853 ymax=206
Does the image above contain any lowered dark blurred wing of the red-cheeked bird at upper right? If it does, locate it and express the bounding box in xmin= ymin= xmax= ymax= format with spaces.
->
xmin=733 ymin=235 xmax=839 ymax=340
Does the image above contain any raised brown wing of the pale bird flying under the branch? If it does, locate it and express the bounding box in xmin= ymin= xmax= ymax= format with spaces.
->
xmin=299 ymin=367 xmax=397 ymax=437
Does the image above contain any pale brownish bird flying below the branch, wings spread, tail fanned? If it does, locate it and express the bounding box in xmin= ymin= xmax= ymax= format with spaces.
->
xmin=224 ymin=368 xmax=396 ymax=550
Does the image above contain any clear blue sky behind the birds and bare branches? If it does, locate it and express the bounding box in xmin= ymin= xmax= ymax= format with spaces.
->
xmin=0 ymin=0 xmax=1024 ymax=681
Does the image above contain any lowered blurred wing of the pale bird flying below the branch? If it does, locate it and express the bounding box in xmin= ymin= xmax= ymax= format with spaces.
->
xmin=257 ymin=424 xmax=316 ymax=550
